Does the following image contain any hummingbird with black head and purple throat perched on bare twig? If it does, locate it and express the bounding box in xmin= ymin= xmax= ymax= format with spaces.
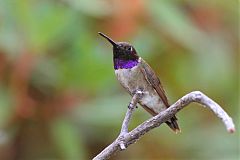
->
xmin=98 ymin=32 xmax=180 ymax=133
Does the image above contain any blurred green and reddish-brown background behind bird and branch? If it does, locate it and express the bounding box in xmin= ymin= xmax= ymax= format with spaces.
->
xmin=0 ymin=0 xmax=240 ymax=160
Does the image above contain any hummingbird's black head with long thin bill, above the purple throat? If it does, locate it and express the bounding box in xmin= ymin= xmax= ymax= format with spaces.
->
xmin=98 ymin=32 xmax=139 ymax=61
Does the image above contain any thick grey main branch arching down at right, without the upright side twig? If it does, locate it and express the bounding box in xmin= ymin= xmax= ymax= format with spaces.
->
xmin=93 ymin=91 xmax=235 ymax=160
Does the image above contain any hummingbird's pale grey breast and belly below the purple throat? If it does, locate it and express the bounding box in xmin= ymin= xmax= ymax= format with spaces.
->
xmin=115 ymin=64 xmax=167 ymax=114
